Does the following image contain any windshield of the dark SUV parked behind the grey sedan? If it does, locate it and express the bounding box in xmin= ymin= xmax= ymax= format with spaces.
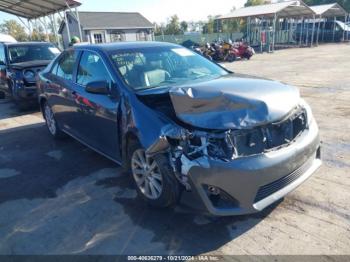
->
xmin=8 ymin=45 xmax=60 ymax=64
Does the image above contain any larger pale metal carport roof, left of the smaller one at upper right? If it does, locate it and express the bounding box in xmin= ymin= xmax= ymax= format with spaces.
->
xmin=220 ymin=1 xmax=315 ymax=19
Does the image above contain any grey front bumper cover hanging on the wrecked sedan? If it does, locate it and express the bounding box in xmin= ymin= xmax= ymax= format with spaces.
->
xmin=187 ymin=121 xmax=322 ymax=216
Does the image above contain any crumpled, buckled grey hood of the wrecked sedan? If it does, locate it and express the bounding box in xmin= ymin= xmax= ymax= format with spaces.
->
xmin=169 ymin=74 xmax=300 ymax=130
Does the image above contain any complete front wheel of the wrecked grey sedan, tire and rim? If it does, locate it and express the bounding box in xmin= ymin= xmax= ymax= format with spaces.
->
xmin=129 ymin=143 xmax=181 ymax=208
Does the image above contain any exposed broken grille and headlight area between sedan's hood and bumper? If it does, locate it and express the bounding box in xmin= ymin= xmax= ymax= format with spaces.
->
xmin=146 ymin=106 xmax=309 ymax=190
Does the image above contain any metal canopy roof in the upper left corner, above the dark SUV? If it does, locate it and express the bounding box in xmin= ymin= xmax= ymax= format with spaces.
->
xmin=0 ymin=0 xmax=81 ymax=20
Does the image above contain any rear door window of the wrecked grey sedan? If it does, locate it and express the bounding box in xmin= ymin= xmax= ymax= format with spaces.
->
xmin=52 ymin=51 xmax=77 ymax=80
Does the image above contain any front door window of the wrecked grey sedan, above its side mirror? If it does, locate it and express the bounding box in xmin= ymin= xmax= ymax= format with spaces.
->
xmin=77 ymin=51 xmax=112 ymax=86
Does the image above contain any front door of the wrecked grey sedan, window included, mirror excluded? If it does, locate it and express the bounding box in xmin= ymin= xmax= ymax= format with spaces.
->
xmin=75 ymin=51 xmax=120 ymax=161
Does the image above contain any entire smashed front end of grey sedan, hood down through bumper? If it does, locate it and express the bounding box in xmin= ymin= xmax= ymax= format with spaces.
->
xmin=135 ymin=74 xmax=321 ymax=215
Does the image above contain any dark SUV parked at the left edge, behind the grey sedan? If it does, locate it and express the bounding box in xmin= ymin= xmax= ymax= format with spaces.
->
xmin=0 ymin=42 xmax=60 ymax=109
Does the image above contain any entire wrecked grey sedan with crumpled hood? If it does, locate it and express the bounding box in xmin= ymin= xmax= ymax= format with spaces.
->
xmin=37 ymin=42 xmax=321 ymax=215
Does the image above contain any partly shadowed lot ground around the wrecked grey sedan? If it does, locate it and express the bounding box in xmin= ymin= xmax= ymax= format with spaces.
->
xmin=0 ymin=44 xmax=350 ymax=255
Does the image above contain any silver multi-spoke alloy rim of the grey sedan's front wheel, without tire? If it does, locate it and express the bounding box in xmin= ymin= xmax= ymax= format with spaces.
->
xmin=131 ymin=149 xmax=163 ymax=200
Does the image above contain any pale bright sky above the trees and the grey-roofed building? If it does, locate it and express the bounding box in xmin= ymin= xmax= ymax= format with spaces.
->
xmin=0 ymin=0 xmax=246 ymax=23
